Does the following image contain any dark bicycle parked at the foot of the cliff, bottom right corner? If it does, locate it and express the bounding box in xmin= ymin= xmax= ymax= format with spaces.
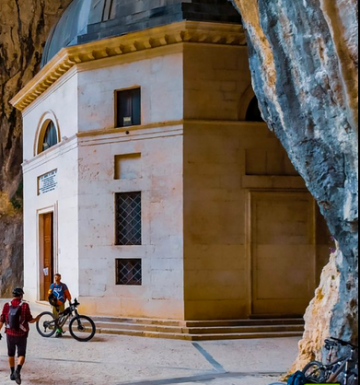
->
xmin=303 ymin=337 xmax=358 ymax=385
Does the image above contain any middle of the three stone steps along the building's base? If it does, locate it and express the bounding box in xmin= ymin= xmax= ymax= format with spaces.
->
xmin=96 ymin=321 xmax=304 ymax=334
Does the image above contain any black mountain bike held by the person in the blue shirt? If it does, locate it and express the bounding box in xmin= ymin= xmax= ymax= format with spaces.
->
xmin=36 ymin=298 xmax=96 ymax=342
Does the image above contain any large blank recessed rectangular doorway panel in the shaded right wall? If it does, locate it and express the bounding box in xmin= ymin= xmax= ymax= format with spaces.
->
xmin=250 ymin=192 xmax=316 ymax=316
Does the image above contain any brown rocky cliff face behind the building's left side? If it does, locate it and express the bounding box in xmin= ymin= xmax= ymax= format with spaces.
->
xmin=0 ymin=0 xmax=71 ymax=296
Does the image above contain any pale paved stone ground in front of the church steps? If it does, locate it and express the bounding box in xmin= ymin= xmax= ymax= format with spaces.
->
xmin=0 ymin=300 xmax=299 ymax=385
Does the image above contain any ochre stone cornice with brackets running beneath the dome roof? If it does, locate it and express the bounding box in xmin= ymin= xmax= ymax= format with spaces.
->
xmin=10 ymin=21 xmax=246 ymax=111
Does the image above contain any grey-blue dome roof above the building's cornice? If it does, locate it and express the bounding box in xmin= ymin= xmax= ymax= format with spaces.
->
xmin=41 ymin=0 xmax=241 ymax=66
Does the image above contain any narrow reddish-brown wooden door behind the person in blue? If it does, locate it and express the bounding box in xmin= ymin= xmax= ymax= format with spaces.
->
xmin=42 ymin=213 xmax=54 ymax=299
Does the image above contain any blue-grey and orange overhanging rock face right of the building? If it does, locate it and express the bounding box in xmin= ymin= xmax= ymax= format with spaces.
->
xmin=233 ymin=0 xmax=358 ymax=368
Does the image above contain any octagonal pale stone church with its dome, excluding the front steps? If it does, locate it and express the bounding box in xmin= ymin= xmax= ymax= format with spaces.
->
xmin=12 ymin=0 xmax=329 ymax=320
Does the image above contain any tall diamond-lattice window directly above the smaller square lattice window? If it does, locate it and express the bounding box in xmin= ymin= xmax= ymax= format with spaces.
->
xmin=115 ymin=192 xmax=141 ymax=245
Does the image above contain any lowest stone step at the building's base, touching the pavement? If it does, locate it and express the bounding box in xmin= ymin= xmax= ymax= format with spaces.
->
xmin=96 ymin=328 xmax=302 ymax=341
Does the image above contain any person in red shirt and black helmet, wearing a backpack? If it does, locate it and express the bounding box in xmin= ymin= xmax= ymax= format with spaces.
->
xmin=0 ymin=287 xmax=39 ymax=384
